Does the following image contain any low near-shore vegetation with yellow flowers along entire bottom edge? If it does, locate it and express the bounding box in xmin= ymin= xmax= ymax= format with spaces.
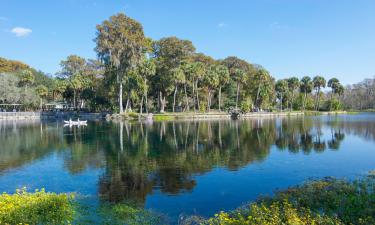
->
xmin=0 ymin=175 xmax=375 ymax=225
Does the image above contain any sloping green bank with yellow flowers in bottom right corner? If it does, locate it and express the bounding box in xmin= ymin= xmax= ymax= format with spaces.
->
xmin=199 ymin=172 xmax=375 ymax=225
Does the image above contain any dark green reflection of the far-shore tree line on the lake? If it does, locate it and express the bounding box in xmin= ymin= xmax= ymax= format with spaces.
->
xmin=0 ymin=117 xmax=375 ymax=207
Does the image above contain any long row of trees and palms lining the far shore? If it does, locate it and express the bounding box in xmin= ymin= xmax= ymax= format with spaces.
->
xmin=0 ymin=13 xmax=375 ymax=113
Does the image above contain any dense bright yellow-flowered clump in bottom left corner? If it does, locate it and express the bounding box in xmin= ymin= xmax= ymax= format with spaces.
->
xmin=0 ymin=188 xmax=74 ymax=224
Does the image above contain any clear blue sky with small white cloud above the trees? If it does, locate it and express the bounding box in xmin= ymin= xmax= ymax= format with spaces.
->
xmin=0 ymin=0 xmax=375 ymax=84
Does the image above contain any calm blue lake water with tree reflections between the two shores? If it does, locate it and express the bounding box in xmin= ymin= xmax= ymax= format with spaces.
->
xmin=0 ymin=114 xmax=375 ymax=223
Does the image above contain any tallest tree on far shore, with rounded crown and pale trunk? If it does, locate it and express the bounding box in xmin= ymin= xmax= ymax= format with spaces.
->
xmin=95 ymin=13 xmax=147 ymax=113
